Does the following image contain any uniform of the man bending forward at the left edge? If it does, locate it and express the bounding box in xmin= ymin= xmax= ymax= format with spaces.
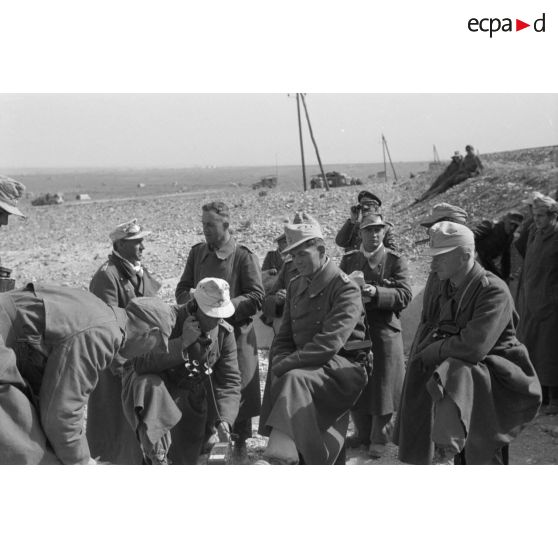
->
xmin=0 ymin=284 xmax=127 ymax=464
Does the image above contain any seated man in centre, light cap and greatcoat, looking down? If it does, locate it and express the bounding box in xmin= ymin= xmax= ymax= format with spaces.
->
xmin=260 ymin=217 xmax=372 ymax=465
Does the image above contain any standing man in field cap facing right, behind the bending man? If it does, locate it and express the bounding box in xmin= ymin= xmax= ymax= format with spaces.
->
xmin=87 ymin=219 xmax=161 ymax=465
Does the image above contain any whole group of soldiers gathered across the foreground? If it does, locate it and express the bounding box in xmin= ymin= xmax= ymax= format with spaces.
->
xmin=0 ymin=177 xmax=558 ymax=465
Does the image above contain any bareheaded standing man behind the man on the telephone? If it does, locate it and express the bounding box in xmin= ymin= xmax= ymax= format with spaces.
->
xmin=175 ymin=202 xmax=264 ymax=459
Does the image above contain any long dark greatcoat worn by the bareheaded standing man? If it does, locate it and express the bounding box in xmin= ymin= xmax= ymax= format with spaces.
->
xmin=175 ymin=237 xmax=264 ymax=422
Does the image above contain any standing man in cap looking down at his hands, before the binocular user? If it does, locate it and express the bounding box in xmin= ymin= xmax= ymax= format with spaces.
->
xmin=341 ymin=214 xmax=413 ymax=459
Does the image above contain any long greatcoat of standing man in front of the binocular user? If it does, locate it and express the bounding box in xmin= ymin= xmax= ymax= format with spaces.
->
xmin=340 ymin=245 xmax=413 ymax=444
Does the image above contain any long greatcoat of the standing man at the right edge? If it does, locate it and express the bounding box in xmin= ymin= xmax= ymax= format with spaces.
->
xmin=517 ymin=223 xmax=558 ymax=387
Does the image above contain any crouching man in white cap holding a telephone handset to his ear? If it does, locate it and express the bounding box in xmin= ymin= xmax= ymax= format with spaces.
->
xmin=123 ymin=277 xmax=240 ymax=465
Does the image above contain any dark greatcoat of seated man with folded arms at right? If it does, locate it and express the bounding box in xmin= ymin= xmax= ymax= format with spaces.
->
xmin=394 ymin=263 xmax=541 ymax=464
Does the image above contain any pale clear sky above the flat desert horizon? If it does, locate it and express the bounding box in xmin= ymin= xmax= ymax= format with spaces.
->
xmin=0 ymin=93 xmax=558 ymax=172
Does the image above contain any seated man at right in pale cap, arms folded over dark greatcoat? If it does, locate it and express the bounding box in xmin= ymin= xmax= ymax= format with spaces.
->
xmin=394 ymin=222 xmax=541 ymax=464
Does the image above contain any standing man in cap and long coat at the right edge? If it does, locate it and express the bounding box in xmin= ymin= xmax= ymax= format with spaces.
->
xmin=518 ymin=195 xmax=558 ymax=414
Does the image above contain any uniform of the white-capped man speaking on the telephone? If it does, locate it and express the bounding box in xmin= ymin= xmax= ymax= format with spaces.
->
xmin=124 ymin=307 xmax=240 ymax=465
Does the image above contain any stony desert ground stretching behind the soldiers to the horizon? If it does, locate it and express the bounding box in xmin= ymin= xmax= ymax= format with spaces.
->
xmin=4 ymin=147 xmax=558 ymax=464
